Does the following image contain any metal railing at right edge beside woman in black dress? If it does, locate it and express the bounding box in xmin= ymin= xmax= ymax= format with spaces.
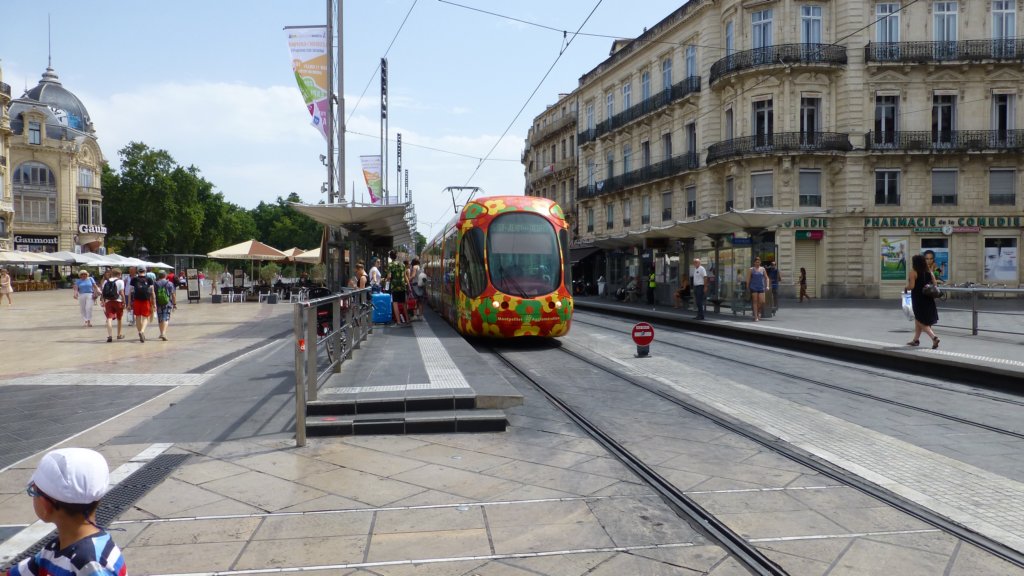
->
xmin=937 ymin=283 xmax=1024 ymax=336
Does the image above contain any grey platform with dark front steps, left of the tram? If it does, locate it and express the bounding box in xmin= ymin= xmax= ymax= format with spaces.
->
xmin=306 ymin=313 xmax=523 ymax=436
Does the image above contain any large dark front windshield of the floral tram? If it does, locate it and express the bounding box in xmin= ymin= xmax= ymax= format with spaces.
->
xmin=487 ymin=212 xmax=562 ymax=297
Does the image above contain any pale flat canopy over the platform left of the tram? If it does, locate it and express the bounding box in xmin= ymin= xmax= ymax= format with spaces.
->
xmin=291 ymin=202 xmax=416 ymax=247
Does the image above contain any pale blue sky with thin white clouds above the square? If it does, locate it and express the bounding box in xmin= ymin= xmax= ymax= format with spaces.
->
xmin=0 ymin=0 xmax=682 ymax=237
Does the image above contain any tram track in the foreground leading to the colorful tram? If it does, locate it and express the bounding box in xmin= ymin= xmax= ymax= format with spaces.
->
xmin=490 ymin=336 xmax=1024 ymax=574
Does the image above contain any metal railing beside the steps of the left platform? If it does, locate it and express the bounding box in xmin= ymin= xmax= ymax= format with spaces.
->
xmin=292 ymin=288 xmax=373 ymax=446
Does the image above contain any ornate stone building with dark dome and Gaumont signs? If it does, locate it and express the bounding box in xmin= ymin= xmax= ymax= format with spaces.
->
xmin=6 ymin=63 xmax=106 ymax=252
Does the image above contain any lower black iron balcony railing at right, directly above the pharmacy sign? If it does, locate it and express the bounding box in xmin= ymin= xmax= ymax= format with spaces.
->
xmin=864 ymin=130 xmax=1024 ymax=153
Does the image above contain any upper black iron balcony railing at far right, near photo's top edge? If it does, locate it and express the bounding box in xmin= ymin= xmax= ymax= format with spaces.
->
xmin=864 ymin=38 xmax=1024 ymax=64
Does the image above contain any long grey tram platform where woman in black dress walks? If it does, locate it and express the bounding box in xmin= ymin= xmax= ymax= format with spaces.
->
xmin=574 ymin=296 xmax=1024 ymax=383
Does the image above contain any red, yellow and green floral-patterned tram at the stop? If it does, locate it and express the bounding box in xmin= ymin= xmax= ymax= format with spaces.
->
xmin=420 ymin=196 xmax=572 ymax=338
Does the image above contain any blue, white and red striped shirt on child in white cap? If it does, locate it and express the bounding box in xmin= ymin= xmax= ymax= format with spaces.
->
xmin=7 ymin=531 xmax=128 ymax=576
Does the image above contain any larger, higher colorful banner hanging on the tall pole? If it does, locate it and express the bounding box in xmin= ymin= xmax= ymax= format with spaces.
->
xmin=285 ymin=26 xmax=331 ymax=139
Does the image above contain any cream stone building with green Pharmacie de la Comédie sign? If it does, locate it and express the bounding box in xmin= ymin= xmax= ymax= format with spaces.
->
xmin=527 ymin=0 xmax=1024 ymax=299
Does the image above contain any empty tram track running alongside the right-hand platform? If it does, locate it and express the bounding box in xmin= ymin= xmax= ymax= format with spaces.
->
xmin=573 ymin=311 xmax=1024 ymax=440
